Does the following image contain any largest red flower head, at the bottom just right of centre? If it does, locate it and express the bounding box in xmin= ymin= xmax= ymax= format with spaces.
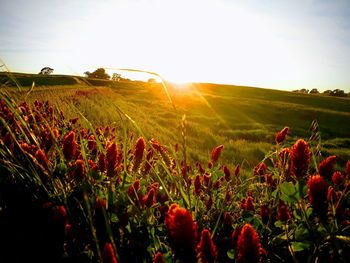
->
xmin=165 ymin=204 xmax=197 ymax=254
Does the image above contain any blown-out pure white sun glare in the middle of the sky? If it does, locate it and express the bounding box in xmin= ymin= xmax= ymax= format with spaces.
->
xmin=42 ymin=0 xmax=326 ymax=87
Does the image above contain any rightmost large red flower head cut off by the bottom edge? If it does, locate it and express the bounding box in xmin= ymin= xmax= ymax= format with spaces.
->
xmin=237 ymin=224 xmax=262 ymax=262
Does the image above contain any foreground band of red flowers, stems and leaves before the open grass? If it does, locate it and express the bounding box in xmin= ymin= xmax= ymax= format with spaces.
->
xmin=0 ymin=94 xmax=350 ymax=262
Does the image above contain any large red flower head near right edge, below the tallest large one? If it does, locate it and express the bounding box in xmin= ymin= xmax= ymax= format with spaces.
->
xmin=307 ymin=175 xmax=328 ymax=215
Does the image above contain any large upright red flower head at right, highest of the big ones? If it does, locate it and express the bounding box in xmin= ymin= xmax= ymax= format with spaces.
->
xmin=290 ymin=139 xmax=310 ymax=178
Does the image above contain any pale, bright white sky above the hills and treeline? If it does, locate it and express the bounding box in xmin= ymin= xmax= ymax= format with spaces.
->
xmin=0 ymin=0 xmax=350 ymax=92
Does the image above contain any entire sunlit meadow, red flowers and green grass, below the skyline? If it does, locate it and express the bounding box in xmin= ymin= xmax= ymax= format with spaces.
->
xmin=0 ymin=73 xmax=350 ymax=263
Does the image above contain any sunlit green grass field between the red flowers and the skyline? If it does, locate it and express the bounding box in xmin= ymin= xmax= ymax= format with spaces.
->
xmin=2 ymin=75 xmax=350 ymax=169
